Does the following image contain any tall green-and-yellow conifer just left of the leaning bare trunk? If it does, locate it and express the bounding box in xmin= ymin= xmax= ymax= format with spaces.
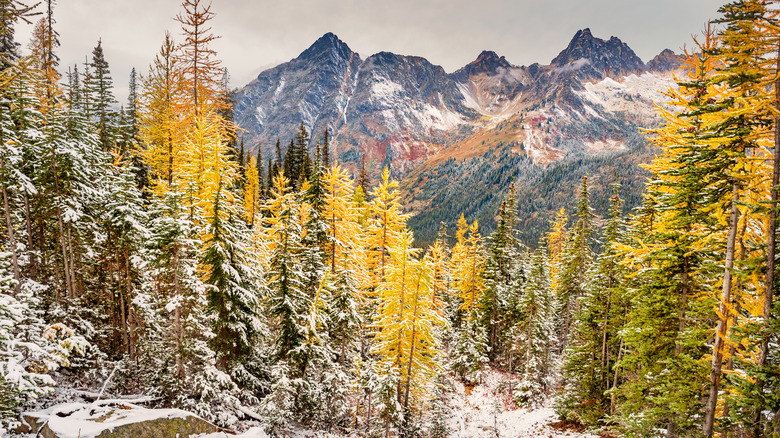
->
xmin=618 ymin=33 xmax=725 ymax=436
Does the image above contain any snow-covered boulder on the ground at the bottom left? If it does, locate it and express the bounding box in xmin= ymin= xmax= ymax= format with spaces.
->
xmin=20 ymin=400 xmax=218 ymax=438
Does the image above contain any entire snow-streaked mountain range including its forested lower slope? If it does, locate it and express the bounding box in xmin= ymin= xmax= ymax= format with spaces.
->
xmin=235 ymin=29 xmax=681 ymax=245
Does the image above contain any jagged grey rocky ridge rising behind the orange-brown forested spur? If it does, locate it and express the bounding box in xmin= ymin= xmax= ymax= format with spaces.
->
xmin=236 ymin=29 xmax=680 ymax=170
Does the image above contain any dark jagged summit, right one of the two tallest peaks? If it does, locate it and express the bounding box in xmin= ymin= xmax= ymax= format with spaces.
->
xmin=551 ymin=28 xmax=645 ymax=76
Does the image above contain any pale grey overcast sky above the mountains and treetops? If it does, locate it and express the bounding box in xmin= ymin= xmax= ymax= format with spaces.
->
xmin=17 ymin=0 xmax=725 ymax=103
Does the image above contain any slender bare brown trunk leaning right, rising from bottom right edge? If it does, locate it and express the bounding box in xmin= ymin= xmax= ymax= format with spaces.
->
xmin=702 ymin=183 xmax=739 ymax=438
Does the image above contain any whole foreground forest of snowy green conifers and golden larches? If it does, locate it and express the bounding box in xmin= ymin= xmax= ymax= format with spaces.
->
xmin=0 ymin=0 xmax=780 ymax=438
